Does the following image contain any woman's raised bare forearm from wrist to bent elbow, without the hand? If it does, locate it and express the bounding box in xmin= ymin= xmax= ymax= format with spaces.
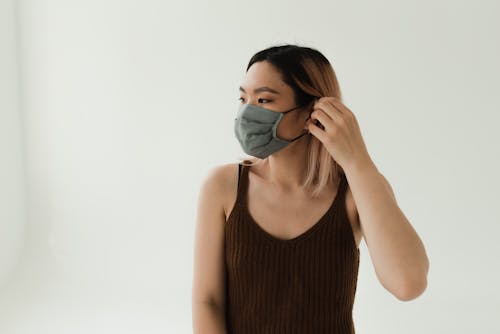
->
xmin=344 ymin=160 xmax=429 ymax=301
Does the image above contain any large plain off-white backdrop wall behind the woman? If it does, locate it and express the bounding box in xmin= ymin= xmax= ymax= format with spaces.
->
xmin=0 ymin=0 xmax=500 ymax=334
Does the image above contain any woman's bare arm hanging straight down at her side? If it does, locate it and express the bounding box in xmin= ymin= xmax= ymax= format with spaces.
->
xmin=192 ymin=166 xmax=227 ymax=334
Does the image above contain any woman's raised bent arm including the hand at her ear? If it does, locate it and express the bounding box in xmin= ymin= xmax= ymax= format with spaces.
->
xmin=307 ymin=97 xmax=429 ymax=301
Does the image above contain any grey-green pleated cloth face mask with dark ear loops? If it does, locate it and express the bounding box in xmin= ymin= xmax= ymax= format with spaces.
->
xmin=234 ymin=104 xmax=312 ymax=159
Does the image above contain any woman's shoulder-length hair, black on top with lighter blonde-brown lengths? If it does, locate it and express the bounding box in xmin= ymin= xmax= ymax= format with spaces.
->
xmin=239 ymin=44 xmax=344 ymax=197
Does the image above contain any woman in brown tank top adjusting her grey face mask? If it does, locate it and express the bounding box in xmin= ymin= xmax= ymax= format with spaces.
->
xmin=192 ymin=45 xmax=429 ymax=334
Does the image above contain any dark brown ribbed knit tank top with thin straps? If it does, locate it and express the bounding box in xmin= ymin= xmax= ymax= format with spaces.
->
xmin=224 ymin=163 xmax=360 ymax=334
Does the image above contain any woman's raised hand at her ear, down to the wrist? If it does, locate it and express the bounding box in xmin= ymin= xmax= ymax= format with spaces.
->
xmin=307 ymin=97 xmax=372 ymax=170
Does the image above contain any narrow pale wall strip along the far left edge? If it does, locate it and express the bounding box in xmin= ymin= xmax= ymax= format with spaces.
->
xmin=0 ymin=1 xmax=26 ymax=294
